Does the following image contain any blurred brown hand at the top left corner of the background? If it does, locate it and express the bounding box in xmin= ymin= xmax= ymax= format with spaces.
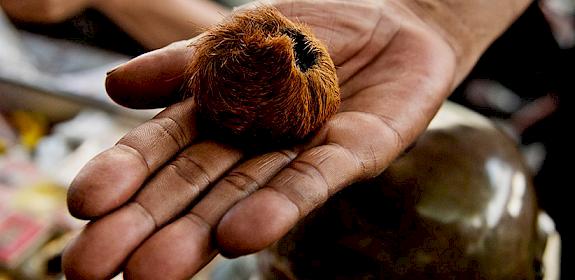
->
xmin=0 ymin=0 xmax=93 ymax=23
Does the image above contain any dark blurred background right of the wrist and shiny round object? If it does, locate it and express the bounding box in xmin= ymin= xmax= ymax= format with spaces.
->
xmin=450 ymin=0 xmax=575 ymax=279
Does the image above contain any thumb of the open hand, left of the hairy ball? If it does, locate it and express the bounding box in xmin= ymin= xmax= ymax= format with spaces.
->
xmin=105 ymin=41 xmax=197 ymax=109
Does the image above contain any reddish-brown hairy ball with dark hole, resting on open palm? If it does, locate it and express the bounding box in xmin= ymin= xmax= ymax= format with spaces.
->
xmin=185 ymin=6 xmax=340 ymax=149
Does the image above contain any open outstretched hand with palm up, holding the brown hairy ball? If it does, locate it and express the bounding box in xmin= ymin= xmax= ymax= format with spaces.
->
xmin=63 ymin=1 xmax=457 ymax=279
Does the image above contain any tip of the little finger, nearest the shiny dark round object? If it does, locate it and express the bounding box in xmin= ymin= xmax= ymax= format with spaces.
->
xmin=216 ymin=188 xmax=299 ymax=257
